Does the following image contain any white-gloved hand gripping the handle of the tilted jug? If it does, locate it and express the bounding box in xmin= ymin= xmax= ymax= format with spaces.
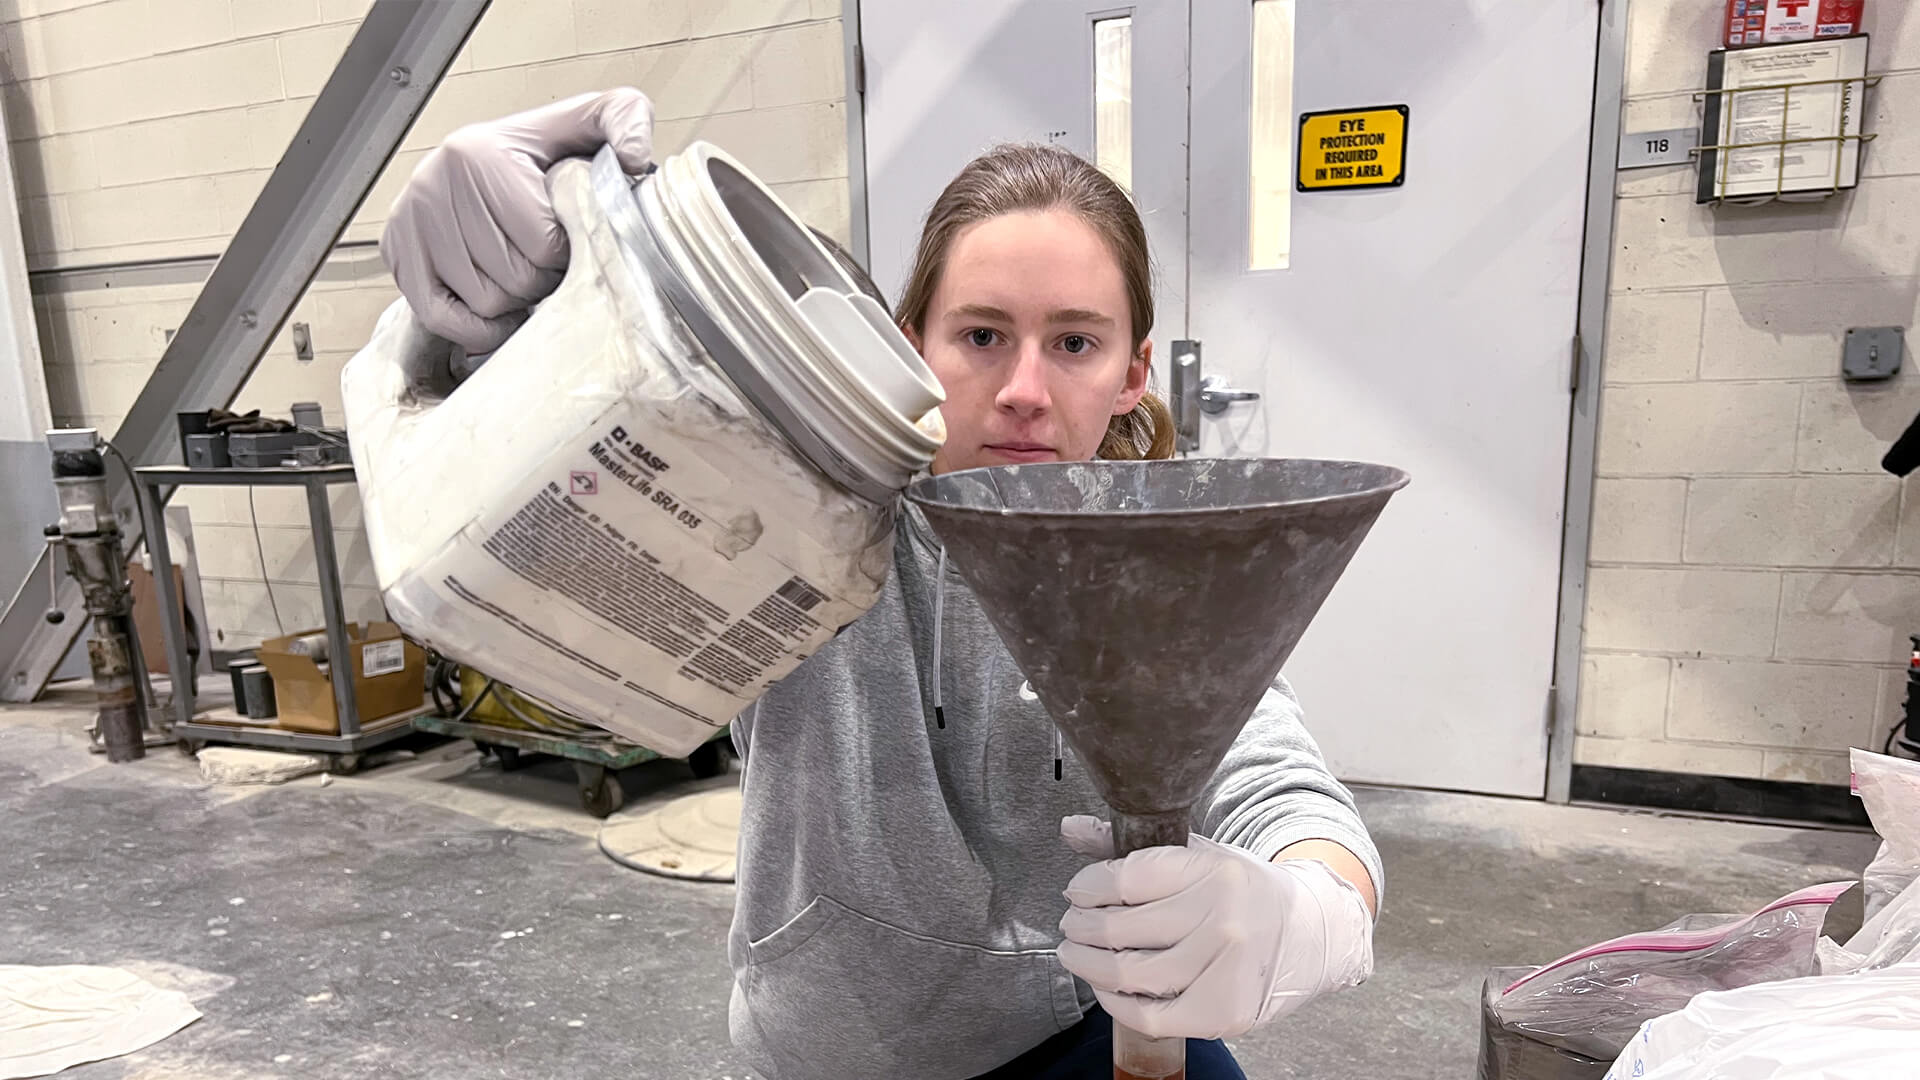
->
xmin=380 ymin=86 xmax=653 ymax=354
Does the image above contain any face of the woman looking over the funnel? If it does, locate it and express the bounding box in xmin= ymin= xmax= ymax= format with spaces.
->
xmin=908 ymin=209 xmax=1152 ymax=473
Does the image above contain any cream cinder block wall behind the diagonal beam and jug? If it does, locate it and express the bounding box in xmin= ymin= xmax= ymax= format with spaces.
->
xmin=0 ymin=0 xmax=849 ymax=648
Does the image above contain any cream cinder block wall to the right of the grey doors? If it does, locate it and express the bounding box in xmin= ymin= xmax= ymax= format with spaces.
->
xmin=1574 ymin=0 xmax=1920 ymax=784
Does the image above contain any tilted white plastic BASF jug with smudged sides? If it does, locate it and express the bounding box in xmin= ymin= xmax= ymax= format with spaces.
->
xmin=342 ymin=142 xmax=945 ymax=755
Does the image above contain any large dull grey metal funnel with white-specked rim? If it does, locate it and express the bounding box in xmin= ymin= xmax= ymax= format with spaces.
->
xmin=906 ymin=459 xmax=1407 ymax=841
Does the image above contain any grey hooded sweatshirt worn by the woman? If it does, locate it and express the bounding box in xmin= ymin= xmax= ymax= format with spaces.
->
xmin=728 ymin=507 xmax=1382 ymax=1080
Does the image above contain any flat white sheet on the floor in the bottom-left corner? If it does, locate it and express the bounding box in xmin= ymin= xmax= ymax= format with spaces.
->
xmin=0 ymin=965 xmax=200 ymax=1080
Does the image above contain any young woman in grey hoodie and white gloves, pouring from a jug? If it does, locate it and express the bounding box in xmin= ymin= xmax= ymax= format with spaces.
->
xmin=382 ymin=88 xmax=1380 ymax=1080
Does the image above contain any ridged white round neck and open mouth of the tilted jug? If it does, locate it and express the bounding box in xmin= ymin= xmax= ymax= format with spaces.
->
xmin=593 ymin=142 xmax=945 ymax=502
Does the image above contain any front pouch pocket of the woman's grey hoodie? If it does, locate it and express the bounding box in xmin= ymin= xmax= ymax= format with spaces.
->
xmin=735 ymin=896 xmax=1073 ymax=1080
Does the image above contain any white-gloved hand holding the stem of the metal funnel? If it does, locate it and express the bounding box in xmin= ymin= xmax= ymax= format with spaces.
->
xmin=1060 ymin=817 xmax=1373 ymax=1040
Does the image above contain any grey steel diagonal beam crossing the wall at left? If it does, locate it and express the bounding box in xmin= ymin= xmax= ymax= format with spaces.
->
xmin=0 ymin=0 xmax=488 ymax=701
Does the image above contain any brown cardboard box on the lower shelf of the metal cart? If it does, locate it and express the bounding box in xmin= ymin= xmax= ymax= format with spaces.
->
xmin=259 ymin=623 xmax=426 ymax=734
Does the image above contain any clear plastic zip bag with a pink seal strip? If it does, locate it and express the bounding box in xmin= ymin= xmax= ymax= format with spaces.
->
xmin=1492 ymin=882 xmax=1853 ymax=1061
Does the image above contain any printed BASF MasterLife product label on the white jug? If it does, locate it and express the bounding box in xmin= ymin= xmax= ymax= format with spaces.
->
xmin=444 ymin=407 xmax=856 ymax=724
